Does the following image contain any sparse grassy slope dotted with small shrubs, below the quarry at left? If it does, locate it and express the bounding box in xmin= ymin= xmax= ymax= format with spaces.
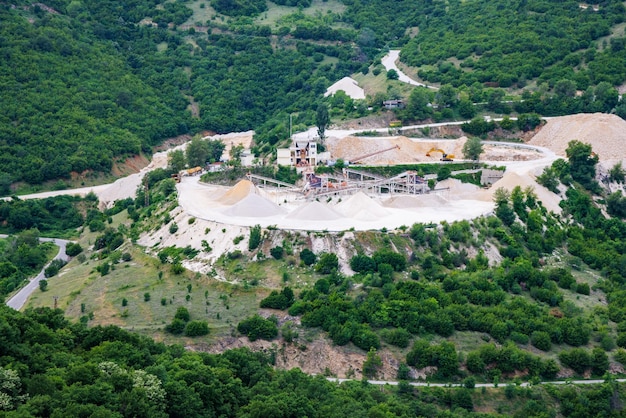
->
xmin=29 ymin=248 xmax=260 ymax=342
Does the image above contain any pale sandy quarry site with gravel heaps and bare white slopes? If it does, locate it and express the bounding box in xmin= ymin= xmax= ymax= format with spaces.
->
xmin=24 ymin=113 xmax=626 ymax=272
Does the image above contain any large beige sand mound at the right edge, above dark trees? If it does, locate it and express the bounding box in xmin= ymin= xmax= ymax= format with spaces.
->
xmin=529 ymin=113 xmax=626 ymax=161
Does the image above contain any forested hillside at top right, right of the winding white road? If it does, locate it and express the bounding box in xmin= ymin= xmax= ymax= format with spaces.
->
xmin=402 ymin=0 xmax=626 ymax=90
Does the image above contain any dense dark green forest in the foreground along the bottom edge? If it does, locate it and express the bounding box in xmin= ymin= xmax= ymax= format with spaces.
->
xmin=0 ymin=307 xmax=624 ymax=418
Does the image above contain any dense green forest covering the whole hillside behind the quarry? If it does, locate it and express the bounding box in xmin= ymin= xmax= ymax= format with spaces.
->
xmin=0 ymin=0 xmax=626 ymax=189
